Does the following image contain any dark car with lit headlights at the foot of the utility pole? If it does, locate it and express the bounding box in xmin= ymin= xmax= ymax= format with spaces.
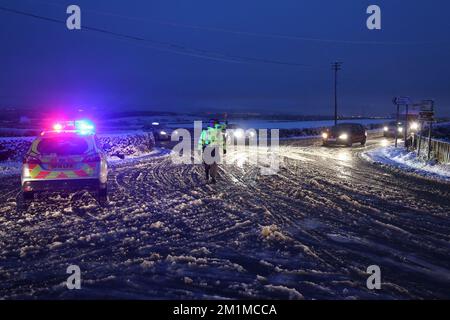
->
xmin=322 ymin=123 xmax=367 ymax=147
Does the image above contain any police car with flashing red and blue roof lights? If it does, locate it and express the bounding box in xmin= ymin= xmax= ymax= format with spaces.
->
xmin=21 ymin=120 xmax=108 ymax=200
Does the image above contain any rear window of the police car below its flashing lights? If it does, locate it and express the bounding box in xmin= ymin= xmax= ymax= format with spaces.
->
xmin=37 ymin=136 xmax=89 ymax=156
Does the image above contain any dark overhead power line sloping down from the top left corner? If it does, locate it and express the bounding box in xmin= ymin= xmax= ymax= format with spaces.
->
xmin=0 ymin=6 xmax=309 ymax=67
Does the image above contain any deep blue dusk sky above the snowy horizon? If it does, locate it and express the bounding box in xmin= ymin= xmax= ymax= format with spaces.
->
xmin=0 ymin=0 xmax=450 ymax=116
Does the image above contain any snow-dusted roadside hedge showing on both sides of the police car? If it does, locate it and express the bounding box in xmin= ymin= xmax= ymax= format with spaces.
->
xmin=0 ymin=132 xmax=155 ymax=161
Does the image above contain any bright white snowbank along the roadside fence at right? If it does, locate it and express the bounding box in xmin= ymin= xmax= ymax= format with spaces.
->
xmin=363 ymin=146 xmax=450 ymax=181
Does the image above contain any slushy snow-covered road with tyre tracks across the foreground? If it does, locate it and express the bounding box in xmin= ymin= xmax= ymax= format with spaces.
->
xmin=0 ymin=139 xmax=450 ymax=299
